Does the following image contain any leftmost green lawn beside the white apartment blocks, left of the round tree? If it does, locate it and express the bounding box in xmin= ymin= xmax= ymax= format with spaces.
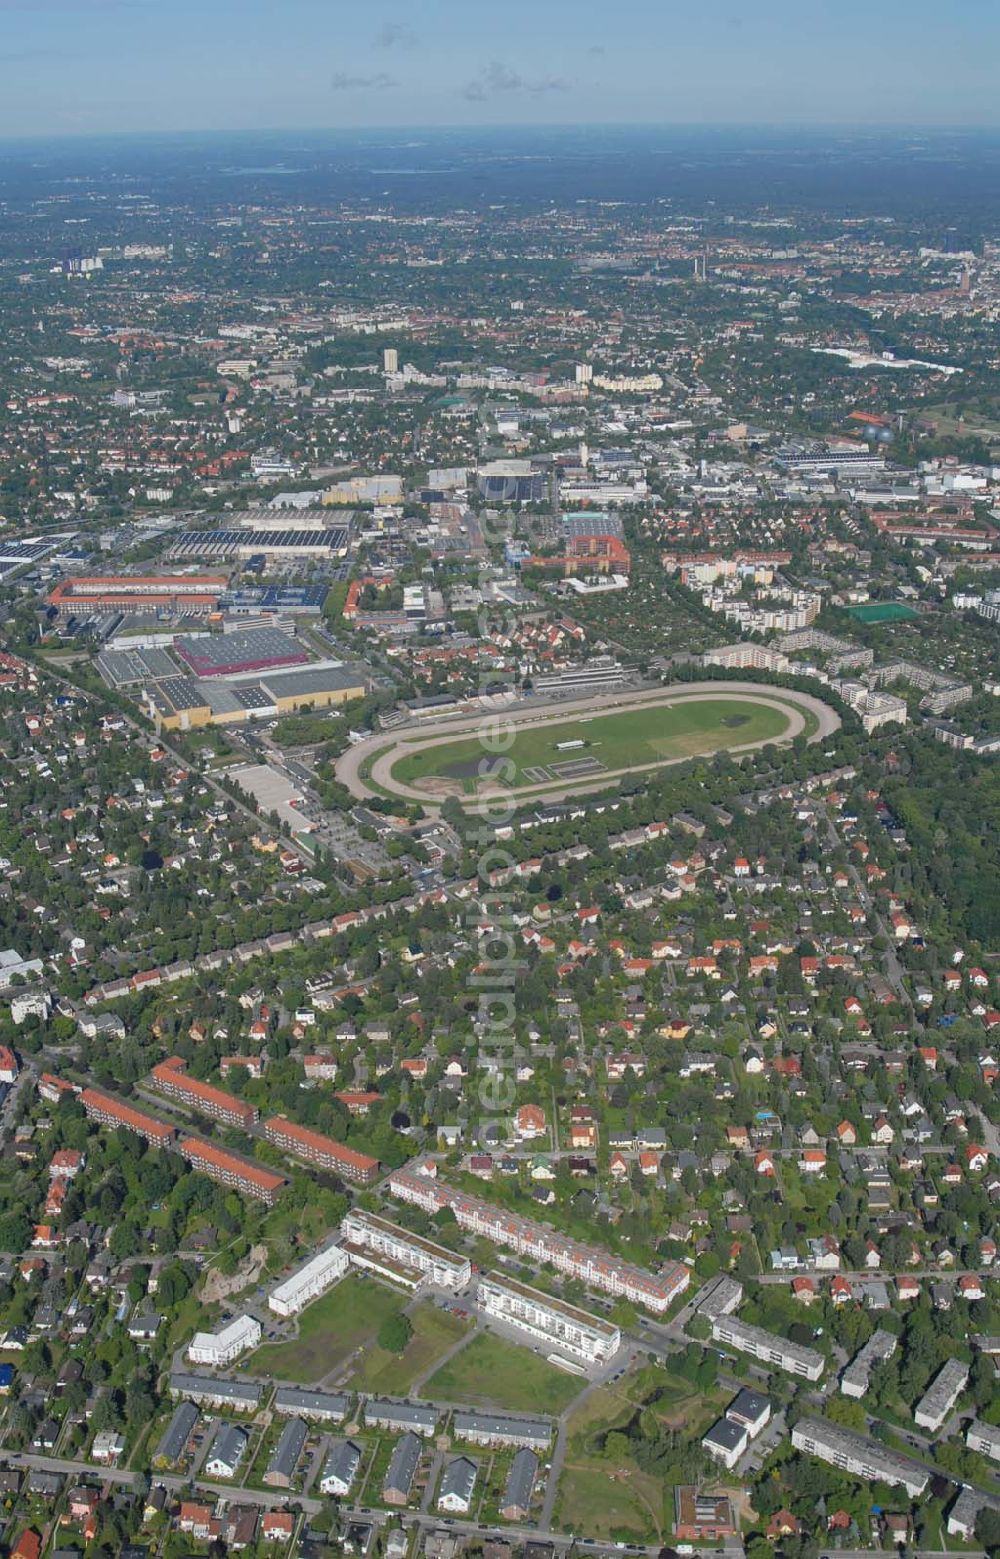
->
xmin=248 ymin=1274 xmax=406 ymax=1386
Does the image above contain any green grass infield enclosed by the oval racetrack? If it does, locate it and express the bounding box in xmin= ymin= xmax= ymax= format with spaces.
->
xmin=392 ymin=697 xmax=791 ymax=794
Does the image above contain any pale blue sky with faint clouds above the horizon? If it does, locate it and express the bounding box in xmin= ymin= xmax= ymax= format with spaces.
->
xmin=0 ymin=0 xmax=1000 ymax=136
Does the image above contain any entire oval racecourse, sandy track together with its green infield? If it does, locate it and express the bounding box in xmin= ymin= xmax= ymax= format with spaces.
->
xmin=337 ymin=681 xmax=839 ymax=804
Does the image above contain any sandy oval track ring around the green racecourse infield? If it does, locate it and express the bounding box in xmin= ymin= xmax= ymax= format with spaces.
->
xmin=337 ymin=681 xmax=841 ymax=809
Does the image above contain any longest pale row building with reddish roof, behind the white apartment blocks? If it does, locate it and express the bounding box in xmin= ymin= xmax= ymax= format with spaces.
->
xmin=388 ymin=1168 xmax=691 ymax=1314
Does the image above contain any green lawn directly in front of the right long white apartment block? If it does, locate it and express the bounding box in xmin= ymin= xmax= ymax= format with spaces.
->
xmin=423 ymin=1331 xmax=587 ymax=1414
